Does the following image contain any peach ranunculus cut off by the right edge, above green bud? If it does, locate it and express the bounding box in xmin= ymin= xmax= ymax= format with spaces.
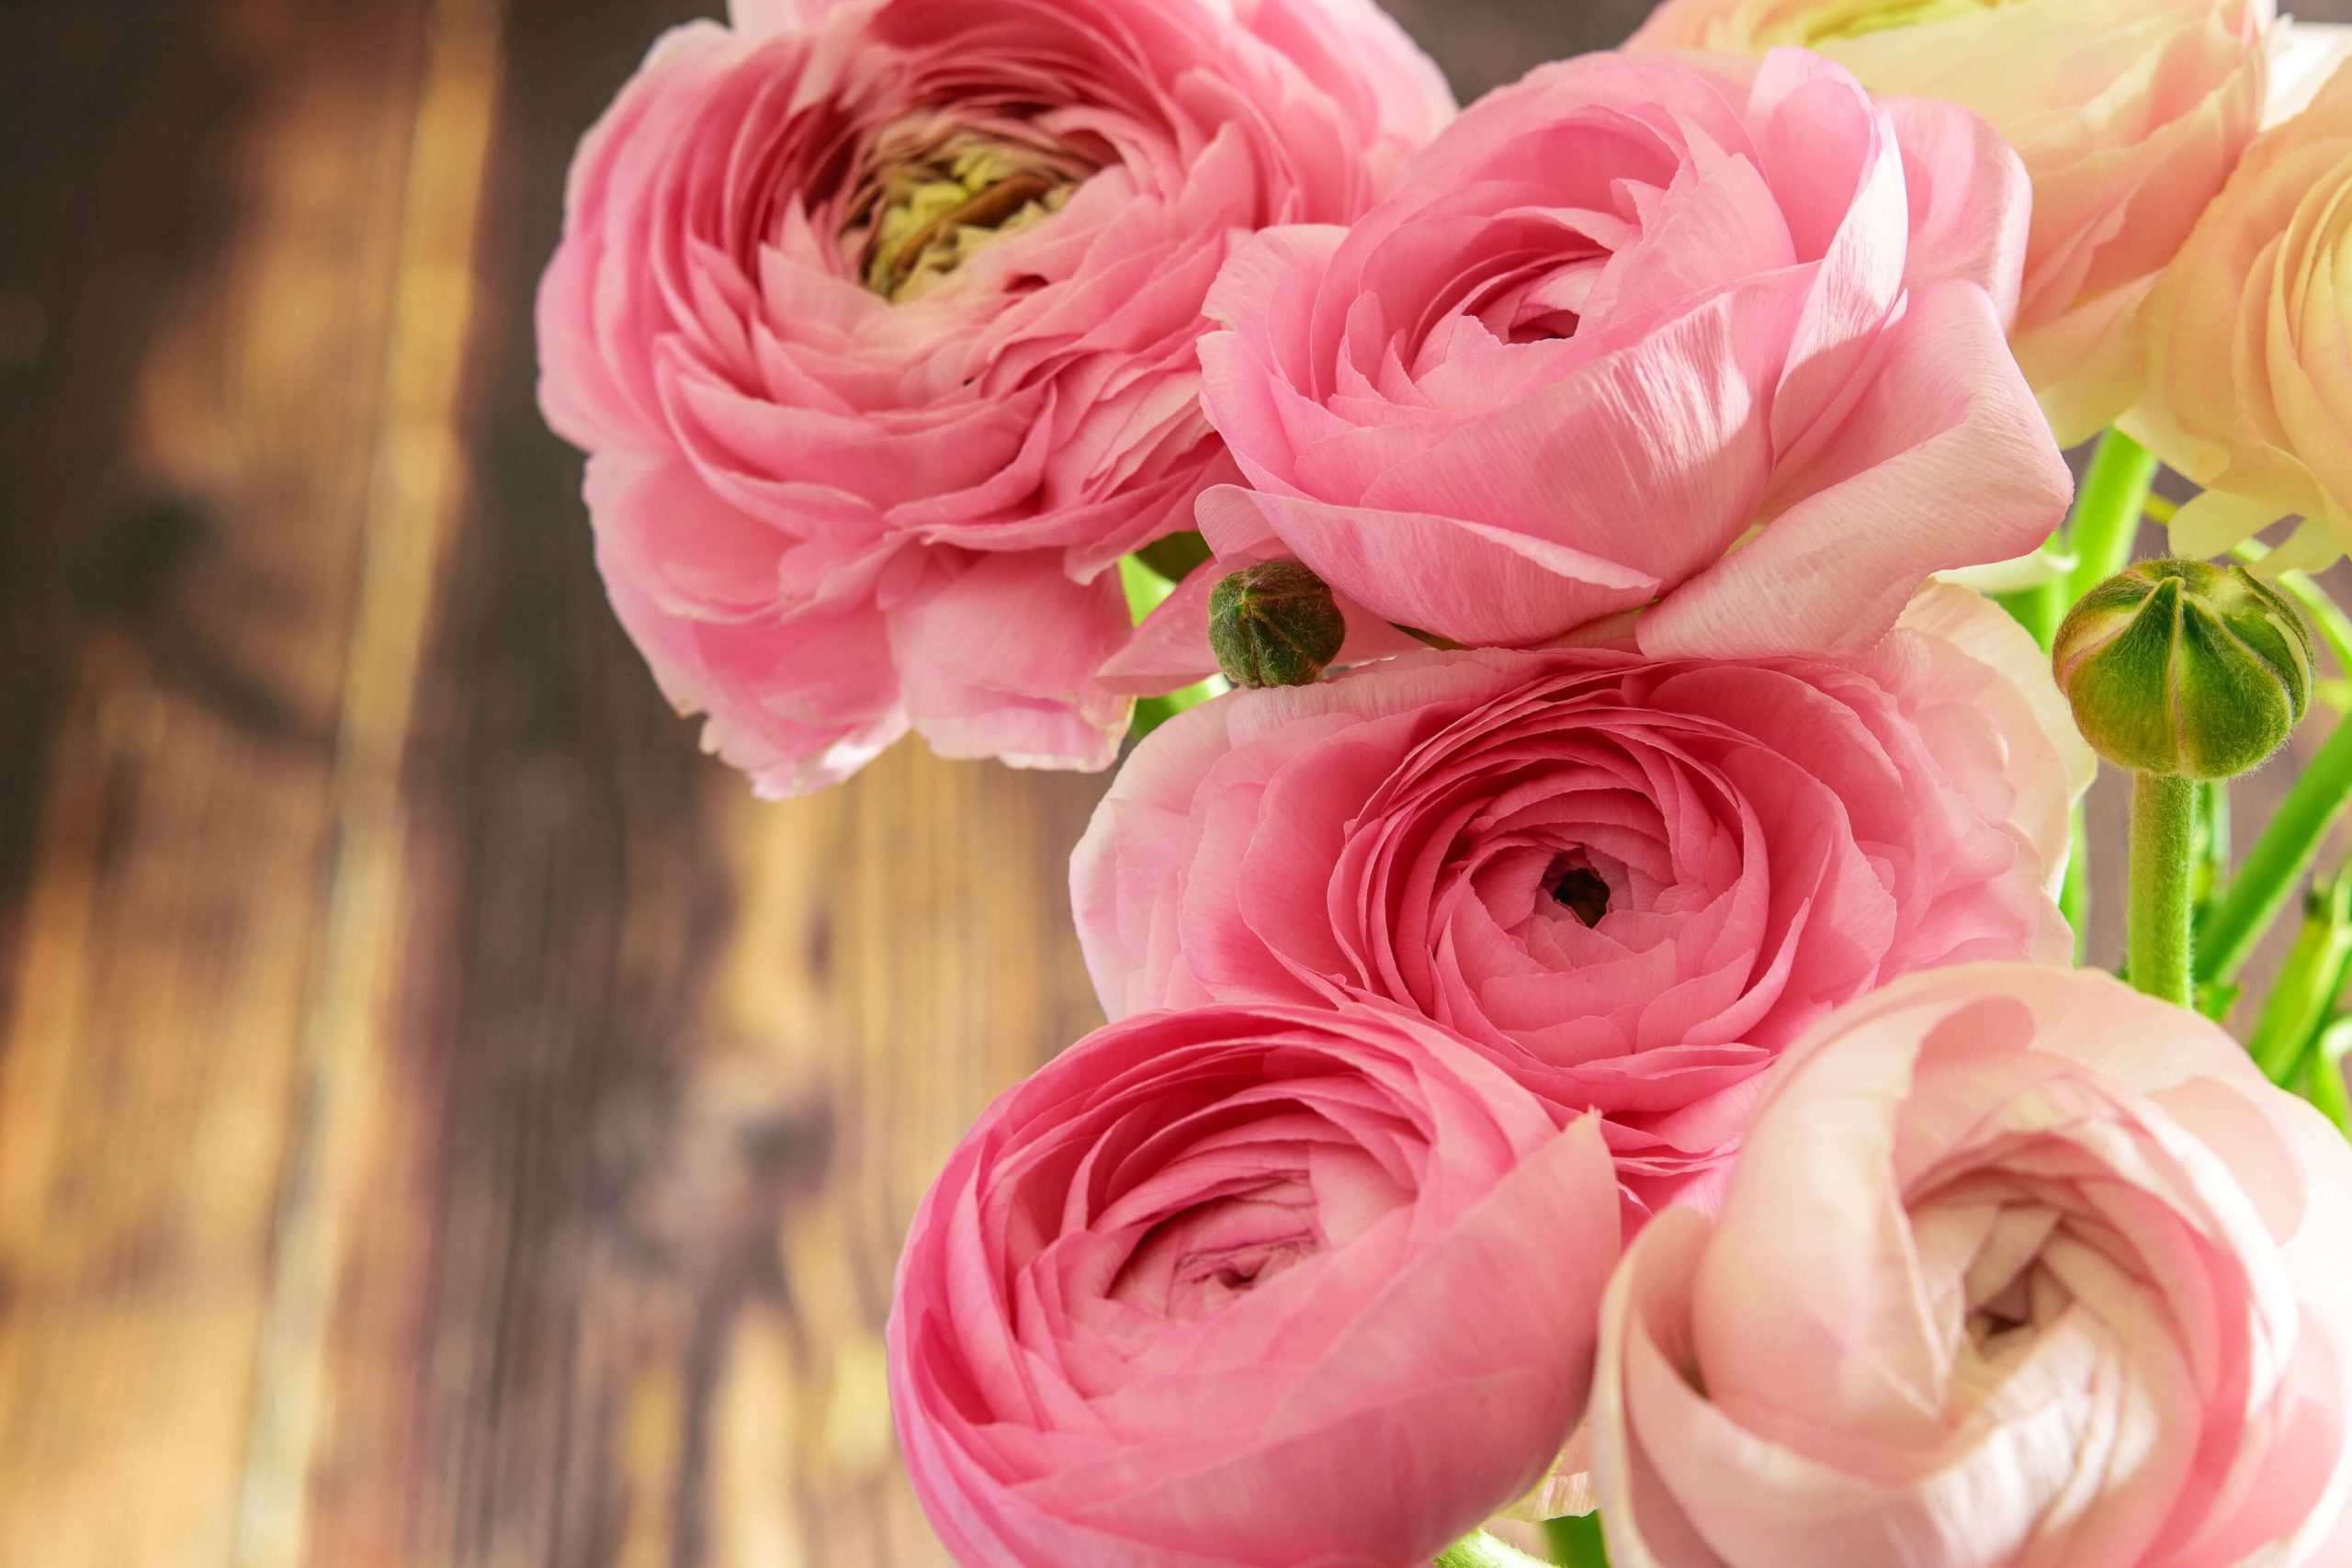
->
xmin=2124 ymin=55 xmax=2352 ymax=567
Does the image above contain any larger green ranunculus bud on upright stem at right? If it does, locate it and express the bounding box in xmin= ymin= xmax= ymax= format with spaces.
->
xmin=2053 ymin=559 xmax=2312 ymax=778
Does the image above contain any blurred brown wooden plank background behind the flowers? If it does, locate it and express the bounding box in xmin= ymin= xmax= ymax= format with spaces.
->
xmin=0 ymin=0 xmax=2345 ymax=1568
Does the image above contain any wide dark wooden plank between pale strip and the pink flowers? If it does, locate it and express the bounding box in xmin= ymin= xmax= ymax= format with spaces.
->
xmin=250 ymin=0 xmax=1101 ymax=1563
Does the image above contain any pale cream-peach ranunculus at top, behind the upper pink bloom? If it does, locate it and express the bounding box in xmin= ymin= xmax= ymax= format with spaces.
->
xmin=1633 ymin=0 xmax=2275 ymax=445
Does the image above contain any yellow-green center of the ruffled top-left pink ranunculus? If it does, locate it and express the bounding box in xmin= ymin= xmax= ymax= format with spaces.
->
xmin=842 ymin=136 xmax=1082 ymax=303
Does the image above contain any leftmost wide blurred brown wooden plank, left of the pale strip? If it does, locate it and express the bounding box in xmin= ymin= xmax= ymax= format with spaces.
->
xmin=0 ymin=0 xmax=433 ymax=1568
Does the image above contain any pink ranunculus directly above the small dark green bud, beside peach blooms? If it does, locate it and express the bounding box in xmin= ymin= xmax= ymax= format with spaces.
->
xmin=1162 ymin=50 xmax=2070 ymax=671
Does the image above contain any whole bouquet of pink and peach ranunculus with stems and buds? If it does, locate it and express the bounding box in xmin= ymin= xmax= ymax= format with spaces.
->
xmin=538 ymin=0 xmax=2352 ymax=1568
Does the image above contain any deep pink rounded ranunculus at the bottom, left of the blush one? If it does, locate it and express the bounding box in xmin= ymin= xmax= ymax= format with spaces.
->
xmin=889 ymin=1009 xmax=1618 ymax=1568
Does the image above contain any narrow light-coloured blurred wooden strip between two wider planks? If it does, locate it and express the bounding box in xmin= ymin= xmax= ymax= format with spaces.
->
xmin=231 ymin=0 xmax=503 ymax=1568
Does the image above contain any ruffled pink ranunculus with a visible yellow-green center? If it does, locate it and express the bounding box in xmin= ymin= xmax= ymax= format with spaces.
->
xmin=538 ymin=0 xmax=1452 ymax=795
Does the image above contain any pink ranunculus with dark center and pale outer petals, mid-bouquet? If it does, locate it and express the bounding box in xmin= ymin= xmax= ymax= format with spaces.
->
xmin=1070 ymin=585 xmax=2093 ymax=1201
